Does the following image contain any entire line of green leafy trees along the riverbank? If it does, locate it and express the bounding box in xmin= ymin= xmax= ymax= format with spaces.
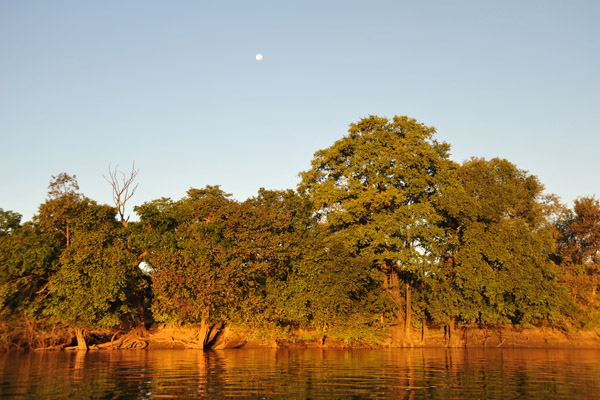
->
xmin=0 ymin=116 xmax=600 ymax=347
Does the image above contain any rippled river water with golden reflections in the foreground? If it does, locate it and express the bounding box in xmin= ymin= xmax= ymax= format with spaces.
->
xmin=0 ymin=349 xmax=600 ymax=399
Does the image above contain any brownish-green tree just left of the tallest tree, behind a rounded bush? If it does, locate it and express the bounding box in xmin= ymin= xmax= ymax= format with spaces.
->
xmin=225 ymin=189 xmax=312 ymax=329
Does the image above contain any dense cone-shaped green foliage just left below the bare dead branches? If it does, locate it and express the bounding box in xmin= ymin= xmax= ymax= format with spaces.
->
xmin=45 ymin=203 xmax=142 ymax=328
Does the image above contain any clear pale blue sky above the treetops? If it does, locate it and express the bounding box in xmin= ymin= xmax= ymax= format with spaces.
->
xmin=0 ymin=0 xmax=600 ymax=220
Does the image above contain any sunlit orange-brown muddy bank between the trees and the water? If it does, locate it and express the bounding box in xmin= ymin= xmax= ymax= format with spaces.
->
xmin=3 ymin=324 xmax=600 ymax=351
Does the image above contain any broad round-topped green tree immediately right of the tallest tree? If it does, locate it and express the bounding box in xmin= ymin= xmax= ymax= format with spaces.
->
xmin=428 ymin=158 xmax=564 ymax=331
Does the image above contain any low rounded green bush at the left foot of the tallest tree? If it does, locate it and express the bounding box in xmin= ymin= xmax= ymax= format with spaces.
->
xmin=274 ymin=231 xmax=389 ymax=343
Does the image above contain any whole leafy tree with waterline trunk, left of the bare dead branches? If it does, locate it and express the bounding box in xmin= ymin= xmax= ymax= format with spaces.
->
xmin=34 ymin=173 xmax=143 ymax=348
